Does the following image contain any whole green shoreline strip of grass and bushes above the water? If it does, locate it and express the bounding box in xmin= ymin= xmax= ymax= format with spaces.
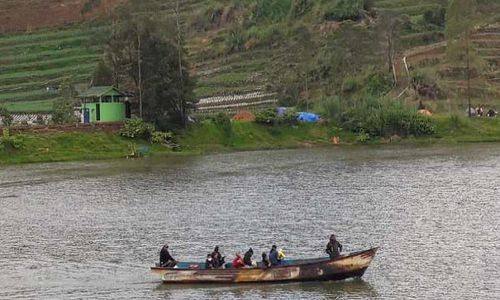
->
xmin=0 ymin=112 xmax=500 ymax=165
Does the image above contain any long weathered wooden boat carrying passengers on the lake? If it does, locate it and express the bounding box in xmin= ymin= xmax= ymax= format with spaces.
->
xmin=151 ymin=248 xmax=378 ymax=284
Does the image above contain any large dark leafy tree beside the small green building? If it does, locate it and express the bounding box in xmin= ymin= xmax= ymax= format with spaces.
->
xmin=106 ymin=0 xmax=194 ymax=128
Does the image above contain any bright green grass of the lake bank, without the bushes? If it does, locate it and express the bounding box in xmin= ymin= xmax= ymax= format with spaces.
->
xmin=0 ymin=116 xmax=500 ymax=165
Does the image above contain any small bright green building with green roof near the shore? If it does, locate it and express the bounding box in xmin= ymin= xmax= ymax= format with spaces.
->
xmin=78 ymin=86 xmax=130 ymax=124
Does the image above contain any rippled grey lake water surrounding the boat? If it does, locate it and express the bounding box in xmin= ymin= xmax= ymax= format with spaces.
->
xmin=0 ymin=144 xmax=500 ymax=299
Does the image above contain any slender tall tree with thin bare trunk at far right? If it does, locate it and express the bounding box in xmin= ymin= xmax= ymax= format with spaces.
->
xmin=446 ymin=0 xmax=479 ymax=117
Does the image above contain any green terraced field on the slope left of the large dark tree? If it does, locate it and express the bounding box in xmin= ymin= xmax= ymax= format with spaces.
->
xmin=0 ymin=26 xmax=105 ymax=112
